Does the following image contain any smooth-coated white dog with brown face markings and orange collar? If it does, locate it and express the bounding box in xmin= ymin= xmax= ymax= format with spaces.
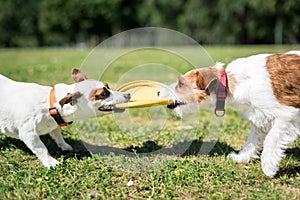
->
xmin=0 ymin=69 xmax=130 ymax=168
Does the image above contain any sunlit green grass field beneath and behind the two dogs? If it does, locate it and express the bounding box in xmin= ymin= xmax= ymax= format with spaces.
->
xmin=0 ymin=46 xmax=300 ymax=199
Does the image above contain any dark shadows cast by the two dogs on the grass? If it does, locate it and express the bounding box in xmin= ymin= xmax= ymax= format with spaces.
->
xmin=0 ymin=135 xmax=300 ymax=177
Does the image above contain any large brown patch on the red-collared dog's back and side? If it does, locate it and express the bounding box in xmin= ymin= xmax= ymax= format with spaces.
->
xmin=267 ymin=54 xmax=300 ymax=108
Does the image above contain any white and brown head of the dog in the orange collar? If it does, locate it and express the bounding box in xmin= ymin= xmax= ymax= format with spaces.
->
xmin=59 ymin=69 xmax=130 ymax=118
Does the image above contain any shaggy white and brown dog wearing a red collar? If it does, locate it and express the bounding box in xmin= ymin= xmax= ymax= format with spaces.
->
xmin=159 ymin=51 xmax=300 ymax=177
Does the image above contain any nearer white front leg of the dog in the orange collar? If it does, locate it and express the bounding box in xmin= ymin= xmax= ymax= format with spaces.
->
xmin=19 ymin=129 xmax=59 ymax=167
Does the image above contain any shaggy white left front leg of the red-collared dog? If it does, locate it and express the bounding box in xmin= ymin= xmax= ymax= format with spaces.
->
xmin=228 ymin=124 xmax=265 ymax=163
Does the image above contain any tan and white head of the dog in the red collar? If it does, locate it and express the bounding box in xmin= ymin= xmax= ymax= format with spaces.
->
xmin=159 ymin=63 xmax=223 ymax=116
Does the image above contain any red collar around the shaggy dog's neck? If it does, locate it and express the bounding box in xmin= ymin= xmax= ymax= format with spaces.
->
xmin=215 ymin=69 xmax=227 ymax=117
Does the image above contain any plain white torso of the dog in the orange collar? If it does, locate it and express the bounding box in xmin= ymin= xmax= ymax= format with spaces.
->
xmin=0 ymin=75 xmax=50 ymax=137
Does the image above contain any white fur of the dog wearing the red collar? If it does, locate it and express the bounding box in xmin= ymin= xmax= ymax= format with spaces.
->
xmin=160 ymin=51 xmax=300 ymax=177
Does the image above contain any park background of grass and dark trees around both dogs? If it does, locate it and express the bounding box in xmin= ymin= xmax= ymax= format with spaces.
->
xmin=0 ymin=0 xmax=300 ymax=199
